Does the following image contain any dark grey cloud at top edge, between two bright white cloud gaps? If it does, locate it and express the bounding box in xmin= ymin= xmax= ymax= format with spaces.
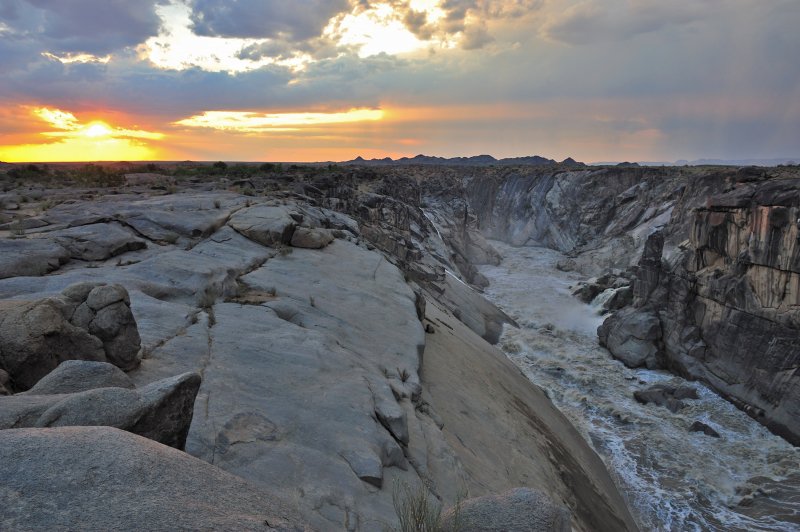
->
xmin=189 ymin=0 xmax=350 ymax=41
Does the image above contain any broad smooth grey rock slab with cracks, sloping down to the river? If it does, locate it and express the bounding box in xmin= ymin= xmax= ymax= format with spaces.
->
xmin=0 ymin=185 xmax=635 ymax=530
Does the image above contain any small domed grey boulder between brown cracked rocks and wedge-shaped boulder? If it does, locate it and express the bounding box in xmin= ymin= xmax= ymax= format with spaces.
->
xmin=24 ymin=360 xmax=135 ymax=395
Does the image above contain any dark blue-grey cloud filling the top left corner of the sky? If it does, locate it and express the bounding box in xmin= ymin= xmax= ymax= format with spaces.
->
xmin=0 ymin=0 xmax=161 ymax=55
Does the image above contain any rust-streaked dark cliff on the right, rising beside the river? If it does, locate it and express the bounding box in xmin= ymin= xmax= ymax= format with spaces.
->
xmin=598 ymin=178 xmax=800 ymax=445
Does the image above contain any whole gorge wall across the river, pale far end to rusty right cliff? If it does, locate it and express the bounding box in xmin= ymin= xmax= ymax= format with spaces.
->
xmin=412 ymin=164 xmax=800 ymax=445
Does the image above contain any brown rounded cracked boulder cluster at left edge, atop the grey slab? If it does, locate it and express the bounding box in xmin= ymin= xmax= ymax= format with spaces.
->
xmin=0 ymin=283 xmax=140 ymax=391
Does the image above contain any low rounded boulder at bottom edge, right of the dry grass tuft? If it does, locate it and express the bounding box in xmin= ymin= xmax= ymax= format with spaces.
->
xmin=442 ymin=488 xmax=572 ymax=532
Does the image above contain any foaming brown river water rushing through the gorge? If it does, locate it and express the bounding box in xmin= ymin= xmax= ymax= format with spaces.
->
xmin=480 ymin=242 xmax=800 ymax=531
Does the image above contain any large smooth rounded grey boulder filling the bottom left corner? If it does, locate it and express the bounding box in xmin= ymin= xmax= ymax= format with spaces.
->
xmin=0 ymin=427 xmax=305 ymax=531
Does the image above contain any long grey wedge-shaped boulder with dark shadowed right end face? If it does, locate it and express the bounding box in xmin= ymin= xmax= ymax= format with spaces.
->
xmin=0 ymin=373 xmax=200 ymax=449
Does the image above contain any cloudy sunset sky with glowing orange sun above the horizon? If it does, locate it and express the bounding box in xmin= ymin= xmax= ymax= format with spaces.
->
xmin=0 ymin=0 xmax=800 ymax=162
